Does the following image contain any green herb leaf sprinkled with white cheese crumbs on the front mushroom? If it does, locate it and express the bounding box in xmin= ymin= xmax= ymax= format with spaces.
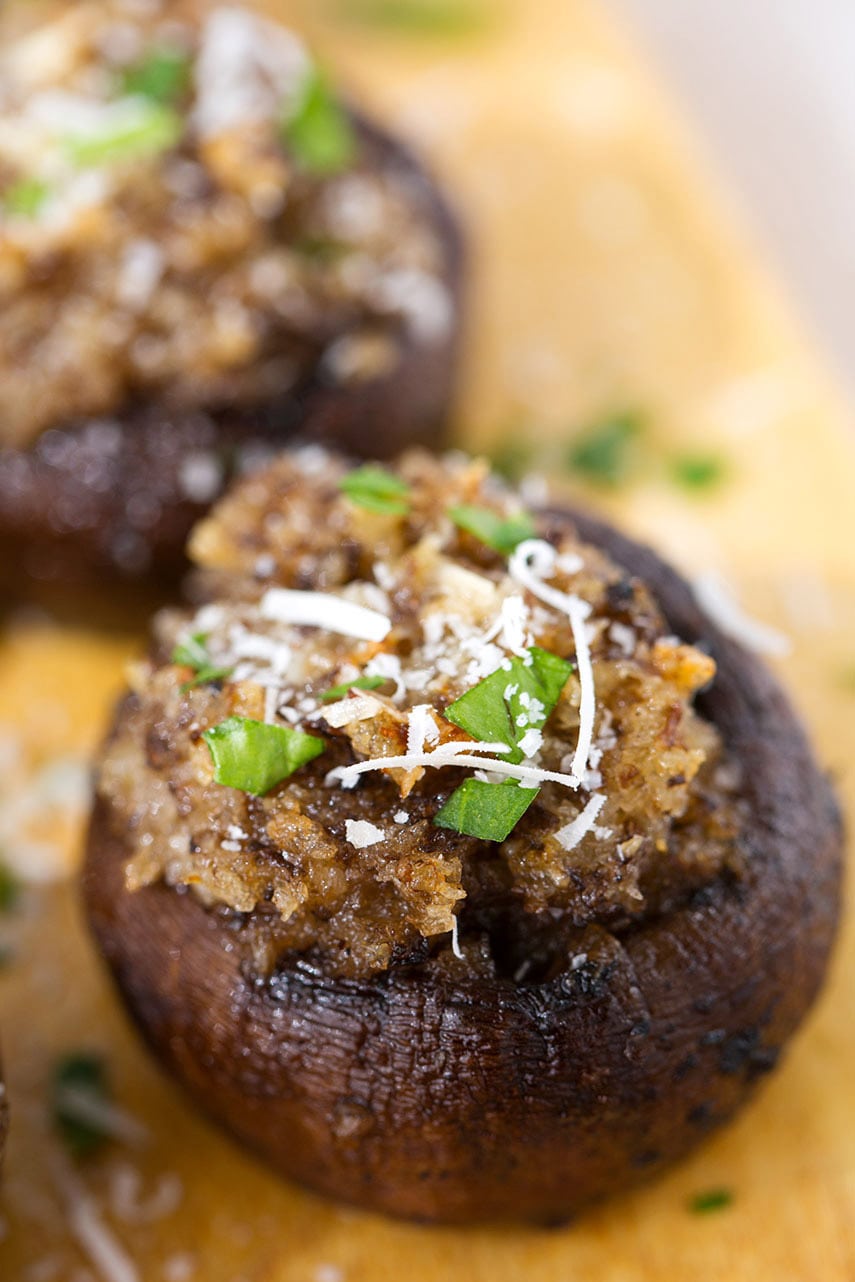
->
xmin=445 ymin=646 xmax=573 ymax=764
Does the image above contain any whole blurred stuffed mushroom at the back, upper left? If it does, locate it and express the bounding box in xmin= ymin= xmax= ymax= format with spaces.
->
xmin=0 ymin=0 xmax=461 ymax=586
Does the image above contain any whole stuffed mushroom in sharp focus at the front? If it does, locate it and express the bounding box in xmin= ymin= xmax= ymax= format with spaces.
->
xmin=85 ymin=450 xmax=841 ymax=1222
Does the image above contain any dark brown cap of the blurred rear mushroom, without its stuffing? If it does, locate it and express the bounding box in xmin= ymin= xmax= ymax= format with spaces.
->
xmin=0 ymin=112 xmax=464 ymax=600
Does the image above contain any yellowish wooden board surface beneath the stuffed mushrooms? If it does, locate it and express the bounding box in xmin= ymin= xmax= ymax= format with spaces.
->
xmin=0 ymin=0 xmax=855 ymax=1282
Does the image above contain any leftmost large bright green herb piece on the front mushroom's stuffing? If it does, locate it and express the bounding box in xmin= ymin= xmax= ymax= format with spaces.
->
xmin=204 ymin=717 xmax=327 ymax=797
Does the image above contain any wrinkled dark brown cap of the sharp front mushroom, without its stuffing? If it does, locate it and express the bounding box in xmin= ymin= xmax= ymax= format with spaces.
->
xmin=85 ymin=513 xmax=842 ymax=1223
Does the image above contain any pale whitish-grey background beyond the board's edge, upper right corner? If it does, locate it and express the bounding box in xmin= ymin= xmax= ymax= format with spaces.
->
xmin=608 ymin=0 xmax=855 ymax=390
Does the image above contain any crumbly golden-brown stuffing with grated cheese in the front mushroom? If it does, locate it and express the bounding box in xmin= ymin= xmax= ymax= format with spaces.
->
xmin=99 ymin=449 xmax=741 ymax=974
